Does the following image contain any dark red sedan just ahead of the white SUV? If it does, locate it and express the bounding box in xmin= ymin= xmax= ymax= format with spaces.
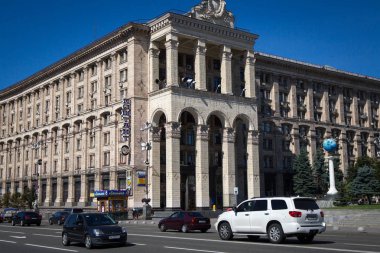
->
xmin=158 ymin=211 xmax=211 ymax=233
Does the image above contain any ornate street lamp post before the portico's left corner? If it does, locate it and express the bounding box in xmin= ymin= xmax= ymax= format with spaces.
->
xmin=140 ymin=122 xmax=152 ymax=220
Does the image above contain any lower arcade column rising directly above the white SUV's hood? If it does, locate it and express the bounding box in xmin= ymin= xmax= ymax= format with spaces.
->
xmin=222 ymin=128 xmax=237 ymax=207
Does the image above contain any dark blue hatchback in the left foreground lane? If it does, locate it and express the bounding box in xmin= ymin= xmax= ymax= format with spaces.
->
xmin=62 ymin=213 xmax=127 ymax=249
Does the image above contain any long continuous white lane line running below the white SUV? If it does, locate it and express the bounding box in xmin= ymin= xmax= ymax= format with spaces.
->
xmin=128 ymin=234 xmax=380 ymax=253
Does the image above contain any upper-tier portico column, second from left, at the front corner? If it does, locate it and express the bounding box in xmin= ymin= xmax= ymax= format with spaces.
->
xmin=165 ymin=33 xmax=179 ymax=86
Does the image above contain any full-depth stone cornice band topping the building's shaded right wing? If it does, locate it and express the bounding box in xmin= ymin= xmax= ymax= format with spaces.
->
xmin=255 ymin=52 xmax=380 ymax=85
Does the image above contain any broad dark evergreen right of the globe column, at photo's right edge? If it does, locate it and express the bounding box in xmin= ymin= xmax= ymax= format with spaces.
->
xmin=349 ymin=165 xmax=380 ymax=204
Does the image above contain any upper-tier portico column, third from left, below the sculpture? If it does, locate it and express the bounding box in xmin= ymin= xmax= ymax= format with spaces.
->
xmin=194 ymin=39 xmax=207 ymax=90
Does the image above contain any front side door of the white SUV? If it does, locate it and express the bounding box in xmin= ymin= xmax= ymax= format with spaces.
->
xmin=232 ymin=200 xmax=254 ymax=233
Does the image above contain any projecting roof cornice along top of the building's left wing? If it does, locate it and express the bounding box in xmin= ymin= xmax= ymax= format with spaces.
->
xmin=0 ymin=23 xmax=150 ymax=99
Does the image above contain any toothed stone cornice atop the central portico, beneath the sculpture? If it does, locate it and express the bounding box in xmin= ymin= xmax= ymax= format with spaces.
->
xmin=148 ymin=13 xmax=259 ymax=46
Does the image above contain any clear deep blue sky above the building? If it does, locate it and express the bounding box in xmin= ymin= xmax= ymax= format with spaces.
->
xmin=0 ymin=0 xmax=380 ymax=89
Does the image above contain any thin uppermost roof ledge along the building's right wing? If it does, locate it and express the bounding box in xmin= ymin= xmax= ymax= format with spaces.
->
xmin=255 ymin=52 xmax=380 ymax=82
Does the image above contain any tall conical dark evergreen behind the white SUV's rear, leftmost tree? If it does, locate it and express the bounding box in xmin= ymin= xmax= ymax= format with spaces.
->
xmin=293 ymin=149 xmax=316 ymax=196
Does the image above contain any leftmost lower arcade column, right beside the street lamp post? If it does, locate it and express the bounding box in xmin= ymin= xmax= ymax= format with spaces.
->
xmin=148 ymin=127 xmax=161 ymax=208
